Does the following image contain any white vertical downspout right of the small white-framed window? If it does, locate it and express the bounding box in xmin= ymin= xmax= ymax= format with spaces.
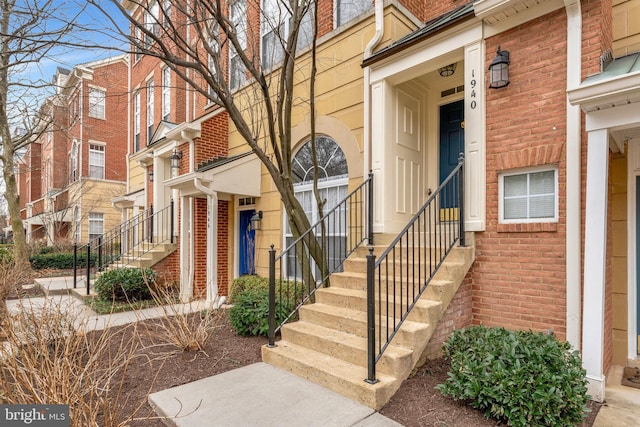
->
xmin=564 ymin=0 xmax=582 ymax=349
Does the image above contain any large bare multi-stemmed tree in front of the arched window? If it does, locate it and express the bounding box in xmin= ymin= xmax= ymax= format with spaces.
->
xmin=92 ymin=0 xmax=326 ymax=282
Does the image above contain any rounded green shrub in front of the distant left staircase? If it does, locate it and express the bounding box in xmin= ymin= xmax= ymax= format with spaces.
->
xmin=94 ymin=268 xmax=156 ymax=302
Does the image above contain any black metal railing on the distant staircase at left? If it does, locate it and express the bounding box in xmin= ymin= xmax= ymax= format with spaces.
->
xmin=73 ymin=200 xmax=175 ymax=295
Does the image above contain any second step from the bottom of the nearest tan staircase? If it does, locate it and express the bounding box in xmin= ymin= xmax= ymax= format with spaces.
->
xmin=282 ymin=321 xmax=413 ymax=375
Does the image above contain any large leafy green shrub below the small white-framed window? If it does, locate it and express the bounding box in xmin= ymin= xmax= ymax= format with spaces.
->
xmin=437 ymin=326 xmax=588 ymax=426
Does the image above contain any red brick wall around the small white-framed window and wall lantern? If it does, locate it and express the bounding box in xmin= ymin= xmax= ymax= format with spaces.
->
xmin=469 ymin=9 xmax=566 ymax=339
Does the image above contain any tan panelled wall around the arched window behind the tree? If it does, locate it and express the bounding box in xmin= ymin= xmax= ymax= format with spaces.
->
xmin=229 ymin=7 xmax=415 ymax=276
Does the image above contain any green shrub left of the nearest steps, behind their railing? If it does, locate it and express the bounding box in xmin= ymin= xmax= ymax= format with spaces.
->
xmin=229 ymin=287 xmax=293 ymax=336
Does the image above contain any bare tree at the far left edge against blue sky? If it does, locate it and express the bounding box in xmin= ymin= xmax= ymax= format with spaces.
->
xmin=0 ymin=0 xmax=89 ymax=267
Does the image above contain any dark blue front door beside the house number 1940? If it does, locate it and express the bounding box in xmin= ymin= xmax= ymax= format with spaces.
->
xmin=438 ymin=100 xmax=464 ymax=208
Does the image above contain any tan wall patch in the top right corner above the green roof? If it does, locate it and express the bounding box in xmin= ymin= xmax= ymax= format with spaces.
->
xmin=613 ymin=0 xmax=640 ymax=58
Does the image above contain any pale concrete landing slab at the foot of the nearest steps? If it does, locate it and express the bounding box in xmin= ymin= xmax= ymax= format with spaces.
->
xmin=149 ymin=362 xmax=401 ymax=427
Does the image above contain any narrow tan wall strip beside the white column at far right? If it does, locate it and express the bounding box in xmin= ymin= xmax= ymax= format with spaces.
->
xmin=609 ymin=153 xmax=628 ymax=366
